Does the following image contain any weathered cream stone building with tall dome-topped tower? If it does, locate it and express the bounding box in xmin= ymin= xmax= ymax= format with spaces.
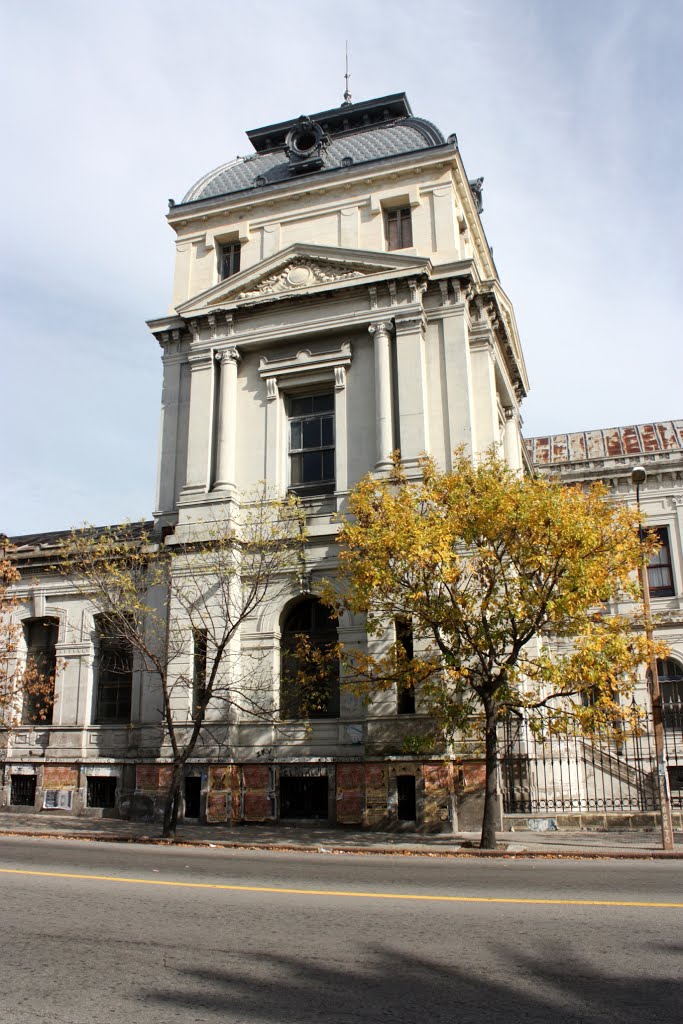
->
xmin=2 ymin=93 xmax=683 ymax=829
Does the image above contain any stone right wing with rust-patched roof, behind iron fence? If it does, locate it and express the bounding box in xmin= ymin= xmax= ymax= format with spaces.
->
xmin=518 ymin=420 xmax=683 ymax=825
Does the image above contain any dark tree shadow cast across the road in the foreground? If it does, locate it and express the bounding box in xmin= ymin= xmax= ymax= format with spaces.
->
xmin=142 ymin=935 xmax=680 ymax=1024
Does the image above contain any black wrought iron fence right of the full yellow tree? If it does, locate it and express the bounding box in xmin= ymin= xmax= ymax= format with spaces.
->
xmin=502 ymin=703 xmax=683 ymax=814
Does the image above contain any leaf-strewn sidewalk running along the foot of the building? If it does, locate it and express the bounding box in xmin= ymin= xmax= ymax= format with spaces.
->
xmin=0 ymin=811 xmax=683 ymax=860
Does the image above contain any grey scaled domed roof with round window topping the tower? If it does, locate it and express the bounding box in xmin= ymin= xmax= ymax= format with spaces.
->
xmin=182 ymin=93 xmax=445 ymax=203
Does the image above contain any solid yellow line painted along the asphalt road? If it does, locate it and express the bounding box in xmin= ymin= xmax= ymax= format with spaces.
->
xmin=0 ymin=867 xmax=683 ymax=909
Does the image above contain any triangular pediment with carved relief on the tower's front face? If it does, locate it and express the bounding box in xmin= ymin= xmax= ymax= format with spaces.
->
xmin=177 ymin=243 xmax=431 ymax=317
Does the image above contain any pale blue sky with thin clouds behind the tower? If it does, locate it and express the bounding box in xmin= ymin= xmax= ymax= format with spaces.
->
xmin=0 ymin=0 xmax=683 ymax=536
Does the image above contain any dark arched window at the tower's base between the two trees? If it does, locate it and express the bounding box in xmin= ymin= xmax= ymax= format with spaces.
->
xmin=281 ymin=597 xmax=339 ymax=718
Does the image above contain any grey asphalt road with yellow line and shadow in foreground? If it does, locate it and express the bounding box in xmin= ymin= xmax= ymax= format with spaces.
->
xmin=0 ymin=838 xmax=683 ymax=1024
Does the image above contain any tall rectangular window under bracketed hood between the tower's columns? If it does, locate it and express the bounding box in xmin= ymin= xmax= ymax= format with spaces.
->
xmin=290 ymin=394 xmax=335 ymax=495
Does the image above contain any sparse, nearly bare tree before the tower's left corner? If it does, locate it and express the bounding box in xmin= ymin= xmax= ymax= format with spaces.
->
xmin=63 ymin=487 xmax=305 ymax=836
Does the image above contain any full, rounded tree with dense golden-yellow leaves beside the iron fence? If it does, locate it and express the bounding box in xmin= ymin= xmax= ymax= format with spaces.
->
xmin=327 ymin=452 xmax=663 ymax=849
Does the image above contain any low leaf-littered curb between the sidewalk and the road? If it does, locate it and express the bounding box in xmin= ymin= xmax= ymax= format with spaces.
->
xmin=0 ymin=829 xmax=683 ymax=860
